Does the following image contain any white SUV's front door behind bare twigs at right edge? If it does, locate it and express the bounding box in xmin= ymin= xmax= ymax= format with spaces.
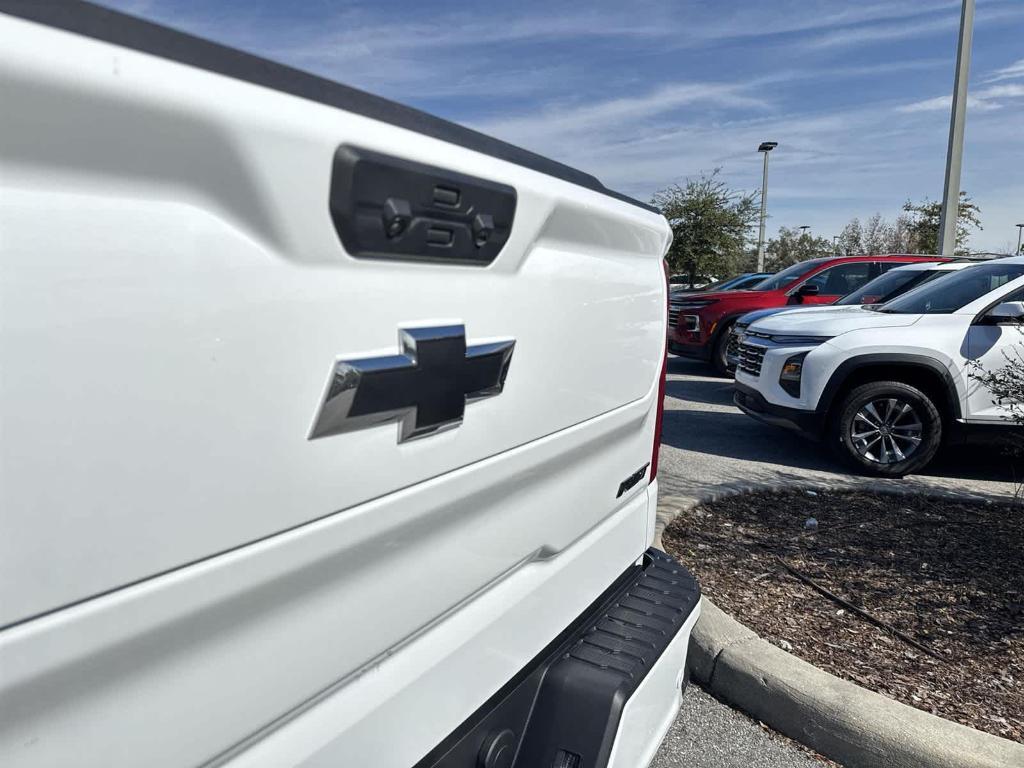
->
xmin=965 ymin=288 xmax=1024 ymax=422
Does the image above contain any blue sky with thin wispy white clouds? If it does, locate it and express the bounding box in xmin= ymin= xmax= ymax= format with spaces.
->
xmin=104 ymin=0 xmax=1024 ymax=250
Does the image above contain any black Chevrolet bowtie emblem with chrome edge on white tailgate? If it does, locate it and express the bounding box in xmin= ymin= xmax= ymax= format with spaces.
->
xmin=309 ymin=326 xmax=515 ymax=442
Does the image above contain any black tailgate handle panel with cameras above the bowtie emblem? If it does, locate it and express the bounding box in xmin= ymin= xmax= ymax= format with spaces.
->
xmin=330 ymin=144 xmax=516 ymax=265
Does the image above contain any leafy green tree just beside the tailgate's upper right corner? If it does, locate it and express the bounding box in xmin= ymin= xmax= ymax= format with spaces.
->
xmin=651 ymin=169 xmax=760 ymax=283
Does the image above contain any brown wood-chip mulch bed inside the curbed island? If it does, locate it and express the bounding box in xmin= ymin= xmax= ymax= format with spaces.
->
xmin=664 ymin=490 xmax=1024 ymax=741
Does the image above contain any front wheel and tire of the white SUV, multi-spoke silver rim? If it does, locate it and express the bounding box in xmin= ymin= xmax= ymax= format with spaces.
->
xmin=828 ymin=381 xmax=942 ymax=477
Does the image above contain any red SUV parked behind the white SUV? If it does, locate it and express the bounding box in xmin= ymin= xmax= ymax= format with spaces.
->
xmin=669 ymin=254 xmax=944 ymax=375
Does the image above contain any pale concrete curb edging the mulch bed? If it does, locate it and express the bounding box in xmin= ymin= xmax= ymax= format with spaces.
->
xmin=657 ymin=481 xmax=1024 ymax=768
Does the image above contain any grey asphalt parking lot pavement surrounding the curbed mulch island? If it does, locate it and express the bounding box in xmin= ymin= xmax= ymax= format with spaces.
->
xmin=653 ymin=357 xmax=1014 ymax=768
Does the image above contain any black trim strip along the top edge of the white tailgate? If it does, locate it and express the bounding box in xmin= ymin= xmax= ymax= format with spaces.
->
xmin=0 ymin=0 xmax=658 ymax=213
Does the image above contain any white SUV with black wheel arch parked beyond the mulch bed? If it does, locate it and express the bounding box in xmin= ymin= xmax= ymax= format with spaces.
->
xmin=735 ymin=257 xmax=1024 ymax=476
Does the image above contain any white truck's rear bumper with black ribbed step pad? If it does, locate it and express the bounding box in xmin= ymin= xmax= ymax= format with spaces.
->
xmin=416 ymin=549 xmax=700 ymax=768
